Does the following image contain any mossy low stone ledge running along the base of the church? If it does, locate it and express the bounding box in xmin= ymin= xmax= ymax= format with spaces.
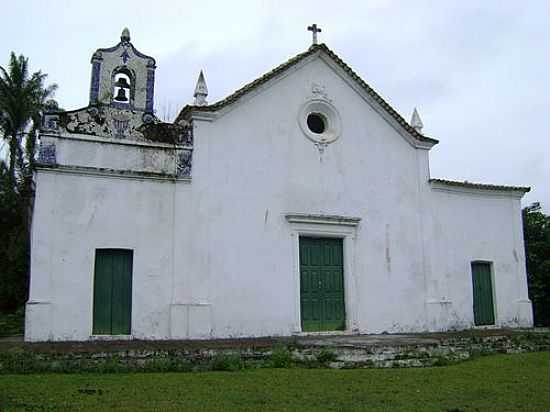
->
xmin=0 ymin=329 xmax=550 ymax=373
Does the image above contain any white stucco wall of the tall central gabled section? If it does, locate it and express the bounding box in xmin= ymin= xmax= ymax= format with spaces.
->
xmin=180 ymin=57 xmax=423 ymax=336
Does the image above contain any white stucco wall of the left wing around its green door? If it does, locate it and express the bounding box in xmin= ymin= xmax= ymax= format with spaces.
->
xmin=26 ymin=171 xmax=174 ymax=340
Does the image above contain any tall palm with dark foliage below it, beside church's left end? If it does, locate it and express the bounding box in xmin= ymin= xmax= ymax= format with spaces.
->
xmin=0 ymin=53 xmax=57 ymax=310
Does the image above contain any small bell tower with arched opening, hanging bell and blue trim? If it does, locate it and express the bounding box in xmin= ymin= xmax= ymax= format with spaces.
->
xmin=90 ymin=28 xmax=156 ymax=119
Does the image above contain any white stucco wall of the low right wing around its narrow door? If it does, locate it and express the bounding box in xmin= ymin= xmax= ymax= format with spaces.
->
xmin=427 ymin=185 xmax=532 ymax=330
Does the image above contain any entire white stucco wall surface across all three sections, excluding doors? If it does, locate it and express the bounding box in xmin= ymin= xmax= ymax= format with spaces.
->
xmin=26 ymin=54 xmax=531 ymax=340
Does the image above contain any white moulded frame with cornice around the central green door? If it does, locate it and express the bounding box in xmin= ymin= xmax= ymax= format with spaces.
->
xmin=285 ymin=213 xmax=361 ymax=335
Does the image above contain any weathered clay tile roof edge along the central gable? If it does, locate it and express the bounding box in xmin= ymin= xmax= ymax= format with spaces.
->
xmin=176 ymin=43 xmax=439 ymax=144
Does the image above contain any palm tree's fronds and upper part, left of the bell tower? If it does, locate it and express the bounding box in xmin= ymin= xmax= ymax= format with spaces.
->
xmin=0 ymin=52 xmax=57 ymax=186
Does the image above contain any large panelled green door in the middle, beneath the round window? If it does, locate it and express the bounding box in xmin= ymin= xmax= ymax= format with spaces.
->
xmin=300 ymin=237 xmax=346 ymax=332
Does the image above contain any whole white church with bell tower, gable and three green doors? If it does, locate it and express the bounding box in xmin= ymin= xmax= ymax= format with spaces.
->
xmin=25 ymin=30 xmax=532 ymax=341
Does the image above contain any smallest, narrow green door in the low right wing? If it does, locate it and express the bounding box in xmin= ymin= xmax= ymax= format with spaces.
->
xmin=472 ymin=262 xmax=495 ymax=325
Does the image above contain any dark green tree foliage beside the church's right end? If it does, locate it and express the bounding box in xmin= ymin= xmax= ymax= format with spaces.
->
xmin=522 ymin=203 xmax=550 ymax=326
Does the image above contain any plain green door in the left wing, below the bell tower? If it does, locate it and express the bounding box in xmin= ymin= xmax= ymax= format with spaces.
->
xmin=93 ymin=249 xmax=133 ymax=335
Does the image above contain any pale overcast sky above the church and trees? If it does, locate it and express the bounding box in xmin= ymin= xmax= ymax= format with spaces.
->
xmin=0 ymin=0 xmax=550 ymax=212
